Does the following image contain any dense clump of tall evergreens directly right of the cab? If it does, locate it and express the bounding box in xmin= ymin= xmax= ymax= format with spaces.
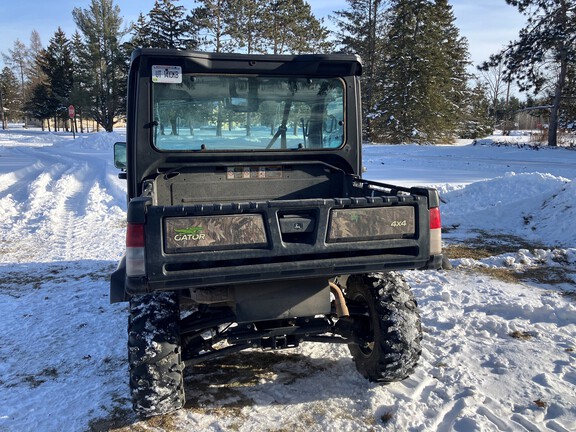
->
xmin=335 ymin=0 xmax=491 ymax=143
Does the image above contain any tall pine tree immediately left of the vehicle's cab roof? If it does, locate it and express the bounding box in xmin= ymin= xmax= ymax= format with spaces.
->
xmin=72 ymin=0 xmax=128 ymax=132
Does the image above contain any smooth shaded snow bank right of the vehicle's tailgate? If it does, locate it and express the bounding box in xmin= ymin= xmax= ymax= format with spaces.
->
xmin=440 ymin=173 xmax=576 ymax=246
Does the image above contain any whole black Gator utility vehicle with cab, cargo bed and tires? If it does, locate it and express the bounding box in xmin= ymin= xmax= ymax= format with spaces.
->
xmin=110 ymin=49 xmax=442 ymax=416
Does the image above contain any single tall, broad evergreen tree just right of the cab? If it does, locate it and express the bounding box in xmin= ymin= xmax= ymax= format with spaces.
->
xmin=376 ymin=0 xmax=468 ymax=143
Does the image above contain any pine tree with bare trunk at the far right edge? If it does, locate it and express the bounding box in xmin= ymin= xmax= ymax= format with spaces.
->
xmin=484 ymin=0 xmax=576 ymax=146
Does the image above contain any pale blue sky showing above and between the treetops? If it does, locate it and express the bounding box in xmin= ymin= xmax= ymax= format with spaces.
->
xmin=0 ymin=0 xmax=525 ymax=66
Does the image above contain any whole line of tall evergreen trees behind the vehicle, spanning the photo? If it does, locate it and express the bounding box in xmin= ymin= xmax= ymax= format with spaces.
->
xmin=0 ymin=0 xmax=576 ymax=144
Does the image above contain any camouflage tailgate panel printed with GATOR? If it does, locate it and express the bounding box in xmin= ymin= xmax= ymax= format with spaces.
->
xmin=164 ymin=214 xmax=268 ymax=253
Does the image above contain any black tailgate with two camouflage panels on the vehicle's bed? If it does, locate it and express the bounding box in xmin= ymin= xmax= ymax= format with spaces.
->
xmin=134 ymin=181 xmax=430 ymax=289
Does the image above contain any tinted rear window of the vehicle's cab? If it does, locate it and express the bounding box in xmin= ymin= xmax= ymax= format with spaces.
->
xmin=152 ymin=75 xmax=344 ymax=151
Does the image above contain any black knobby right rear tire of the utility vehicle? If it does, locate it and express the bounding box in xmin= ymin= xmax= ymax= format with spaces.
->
xmin=346 ymin=272 xmax=422 ymax=383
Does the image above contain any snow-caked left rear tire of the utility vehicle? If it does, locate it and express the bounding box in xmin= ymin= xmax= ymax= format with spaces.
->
xmin=128 ymin=293 xmax=185 ymax=417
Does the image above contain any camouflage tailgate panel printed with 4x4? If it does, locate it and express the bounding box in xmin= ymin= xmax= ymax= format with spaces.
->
xmin=327 ymin=206 xmax=416 ymax=243
